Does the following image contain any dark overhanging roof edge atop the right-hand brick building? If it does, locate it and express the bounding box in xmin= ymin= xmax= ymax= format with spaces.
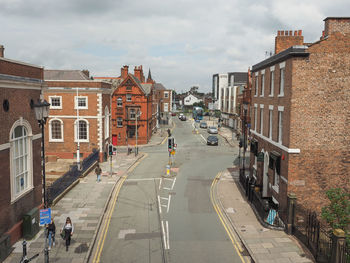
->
xmin=252 ymin=46 xmax=310 ymax=72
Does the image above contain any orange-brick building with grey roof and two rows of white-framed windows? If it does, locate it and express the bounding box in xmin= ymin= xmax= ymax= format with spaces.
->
xmin=44 ymin=70 xmax=112 ymax=161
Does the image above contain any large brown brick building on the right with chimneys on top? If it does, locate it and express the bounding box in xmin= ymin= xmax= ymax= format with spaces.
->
xmin=250 ymin=17 xmax=350 ymax=222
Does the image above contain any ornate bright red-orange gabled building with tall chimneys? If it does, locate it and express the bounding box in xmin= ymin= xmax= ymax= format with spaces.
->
xmin=112 ymin=66 xmax=156 ymax=146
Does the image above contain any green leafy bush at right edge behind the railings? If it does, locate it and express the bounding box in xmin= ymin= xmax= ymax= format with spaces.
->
xmin=321 ymin=188 xmax=350 ymax=234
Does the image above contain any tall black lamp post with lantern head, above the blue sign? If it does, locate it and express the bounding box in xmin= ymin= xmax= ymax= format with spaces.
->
xmin=33 ymin=100 xmax=50 ymax=208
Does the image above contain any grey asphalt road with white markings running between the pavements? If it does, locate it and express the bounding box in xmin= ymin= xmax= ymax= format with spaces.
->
xmin=92 ymin=117 xmax=244 ymax=263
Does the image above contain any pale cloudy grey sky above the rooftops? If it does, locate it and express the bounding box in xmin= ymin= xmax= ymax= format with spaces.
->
xmin=0 ymin=0 xmax=350 ymax=92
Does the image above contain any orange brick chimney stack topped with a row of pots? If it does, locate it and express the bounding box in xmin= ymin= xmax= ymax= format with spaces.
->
xmin=275 ymin=30 xmax=304 ymax=54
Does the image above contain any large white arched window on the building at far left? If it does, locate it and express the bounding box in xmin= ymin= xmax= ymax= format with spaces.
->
xmin=10 ymin=119 xmax=33 ymax=201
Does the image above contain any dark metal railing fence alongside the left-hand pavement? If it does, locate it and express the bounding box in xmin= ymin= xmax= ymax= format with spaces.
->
xmin=46 ymin=149 xmax=99 ymax=206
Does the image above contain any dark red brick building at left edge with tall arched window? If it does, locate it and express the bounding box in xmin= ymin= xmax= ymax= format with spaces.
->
xmin=0 ymin=46 xmax=44 ymax=252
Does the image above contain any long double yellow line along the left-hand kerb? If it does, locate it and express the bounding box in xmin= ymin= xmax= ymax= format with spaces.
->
xmin=92 ymin=154 xmax=148 ymax=263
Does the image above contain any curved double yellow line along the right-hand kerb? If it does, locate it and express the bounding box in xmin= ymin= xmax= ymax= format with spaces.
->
xmin=210 ymin=172 xmax=246 ymax=263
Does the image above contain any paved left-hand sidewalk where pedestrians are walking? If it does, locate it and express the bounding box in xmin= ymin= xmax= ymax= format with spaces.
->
xmin=4 ymin=153 xmax=143 ymax=263
